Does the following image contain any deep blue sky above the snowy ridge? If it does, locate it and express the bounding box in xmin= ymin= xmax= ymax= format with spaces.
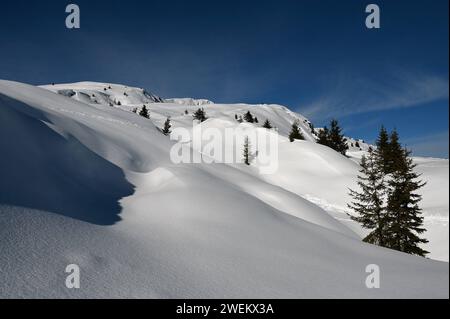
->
xmin=0 ymin=0 xmax=449 ymax=157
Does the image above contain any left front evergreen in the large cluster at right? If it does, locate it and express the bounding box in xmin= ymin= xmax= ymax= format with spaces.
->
xmin=348 ymin=152 xmax=388 ymax=246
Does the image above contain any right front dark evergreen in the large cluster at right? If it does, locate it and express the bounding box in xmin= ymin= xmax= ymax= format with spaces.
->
xmin=387 ymin=148 xmax=428 ymax=257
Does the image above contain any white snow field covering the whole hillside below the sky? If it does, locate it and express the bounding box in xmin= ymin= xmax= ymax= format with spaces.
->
xmin=0 ymin=81 xmax=449 ymax=298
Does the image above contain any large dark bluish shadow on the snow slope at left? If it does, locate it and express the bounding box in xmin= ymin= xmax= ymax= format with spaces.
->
xmin=0 ymin=95 xmax=134 ymax=225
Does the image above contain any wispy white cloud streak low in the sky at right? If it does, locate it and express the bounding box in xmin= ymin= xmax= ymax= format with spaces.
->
xmin=299 ymin=71 xmax=449 ymax=119
